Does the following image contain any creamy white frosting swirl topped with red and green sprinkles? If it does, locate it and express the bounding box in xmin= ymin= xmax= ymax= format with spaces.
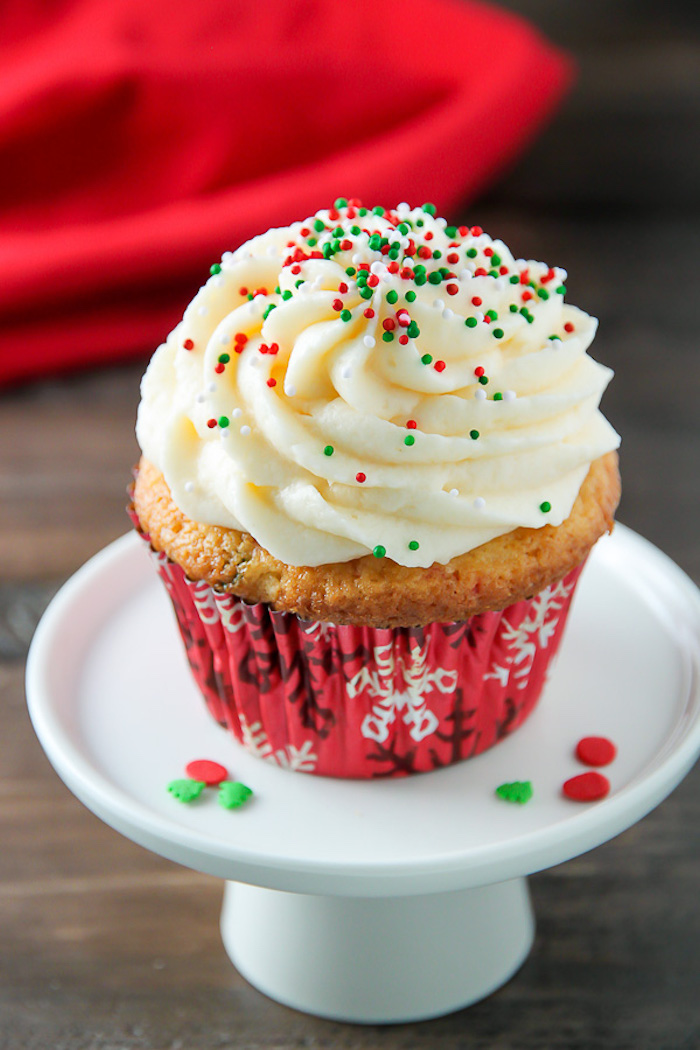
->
xmin=136 ymin=201 xmax=619 ymax=566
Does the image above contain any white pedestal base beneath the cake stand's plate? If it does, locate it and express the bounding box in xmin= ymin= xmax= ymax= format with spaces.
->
xmin=221 ymin=878 xmax=534 ymax=1024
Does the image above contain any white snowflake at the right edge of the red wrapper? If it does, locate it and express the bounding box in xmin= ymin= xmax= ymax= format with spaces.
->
xmin=484 ymin=580 xmax=574 ymax=689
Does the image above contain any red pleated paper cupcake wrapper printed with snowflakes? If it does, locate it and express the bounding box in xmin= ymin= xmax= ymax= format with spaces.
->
xmin=130 ymin=512 xmax=582 ymax=778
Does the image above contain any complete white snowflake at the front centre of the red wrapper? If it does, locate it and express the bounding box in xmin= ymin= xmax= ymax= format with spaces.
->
xmin=346 ymin=644 xmax=458 ymax=743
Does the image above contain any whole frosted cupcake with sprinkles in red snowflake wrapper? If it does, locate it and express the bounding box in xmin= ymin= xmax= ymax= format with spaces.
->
xmin=131 ymin=198 xmax=619 ymax=777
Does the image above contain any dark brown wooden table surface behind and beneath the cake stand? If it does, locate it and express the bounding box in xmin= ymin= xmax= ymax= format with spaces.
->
xmin=0 ymin=0 xmax=700 ymax=1050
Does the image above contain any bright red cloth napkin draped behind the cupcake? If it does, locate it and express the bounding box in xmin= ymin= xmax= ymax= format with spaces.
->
xmin=0 ymin=0 xmax=571 ymax=383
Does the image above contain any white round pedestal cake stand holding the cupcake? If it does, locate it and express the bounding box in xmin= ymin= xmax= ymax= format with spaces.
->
xmin=27 ymin=526 xmax=700 ymax=1023
